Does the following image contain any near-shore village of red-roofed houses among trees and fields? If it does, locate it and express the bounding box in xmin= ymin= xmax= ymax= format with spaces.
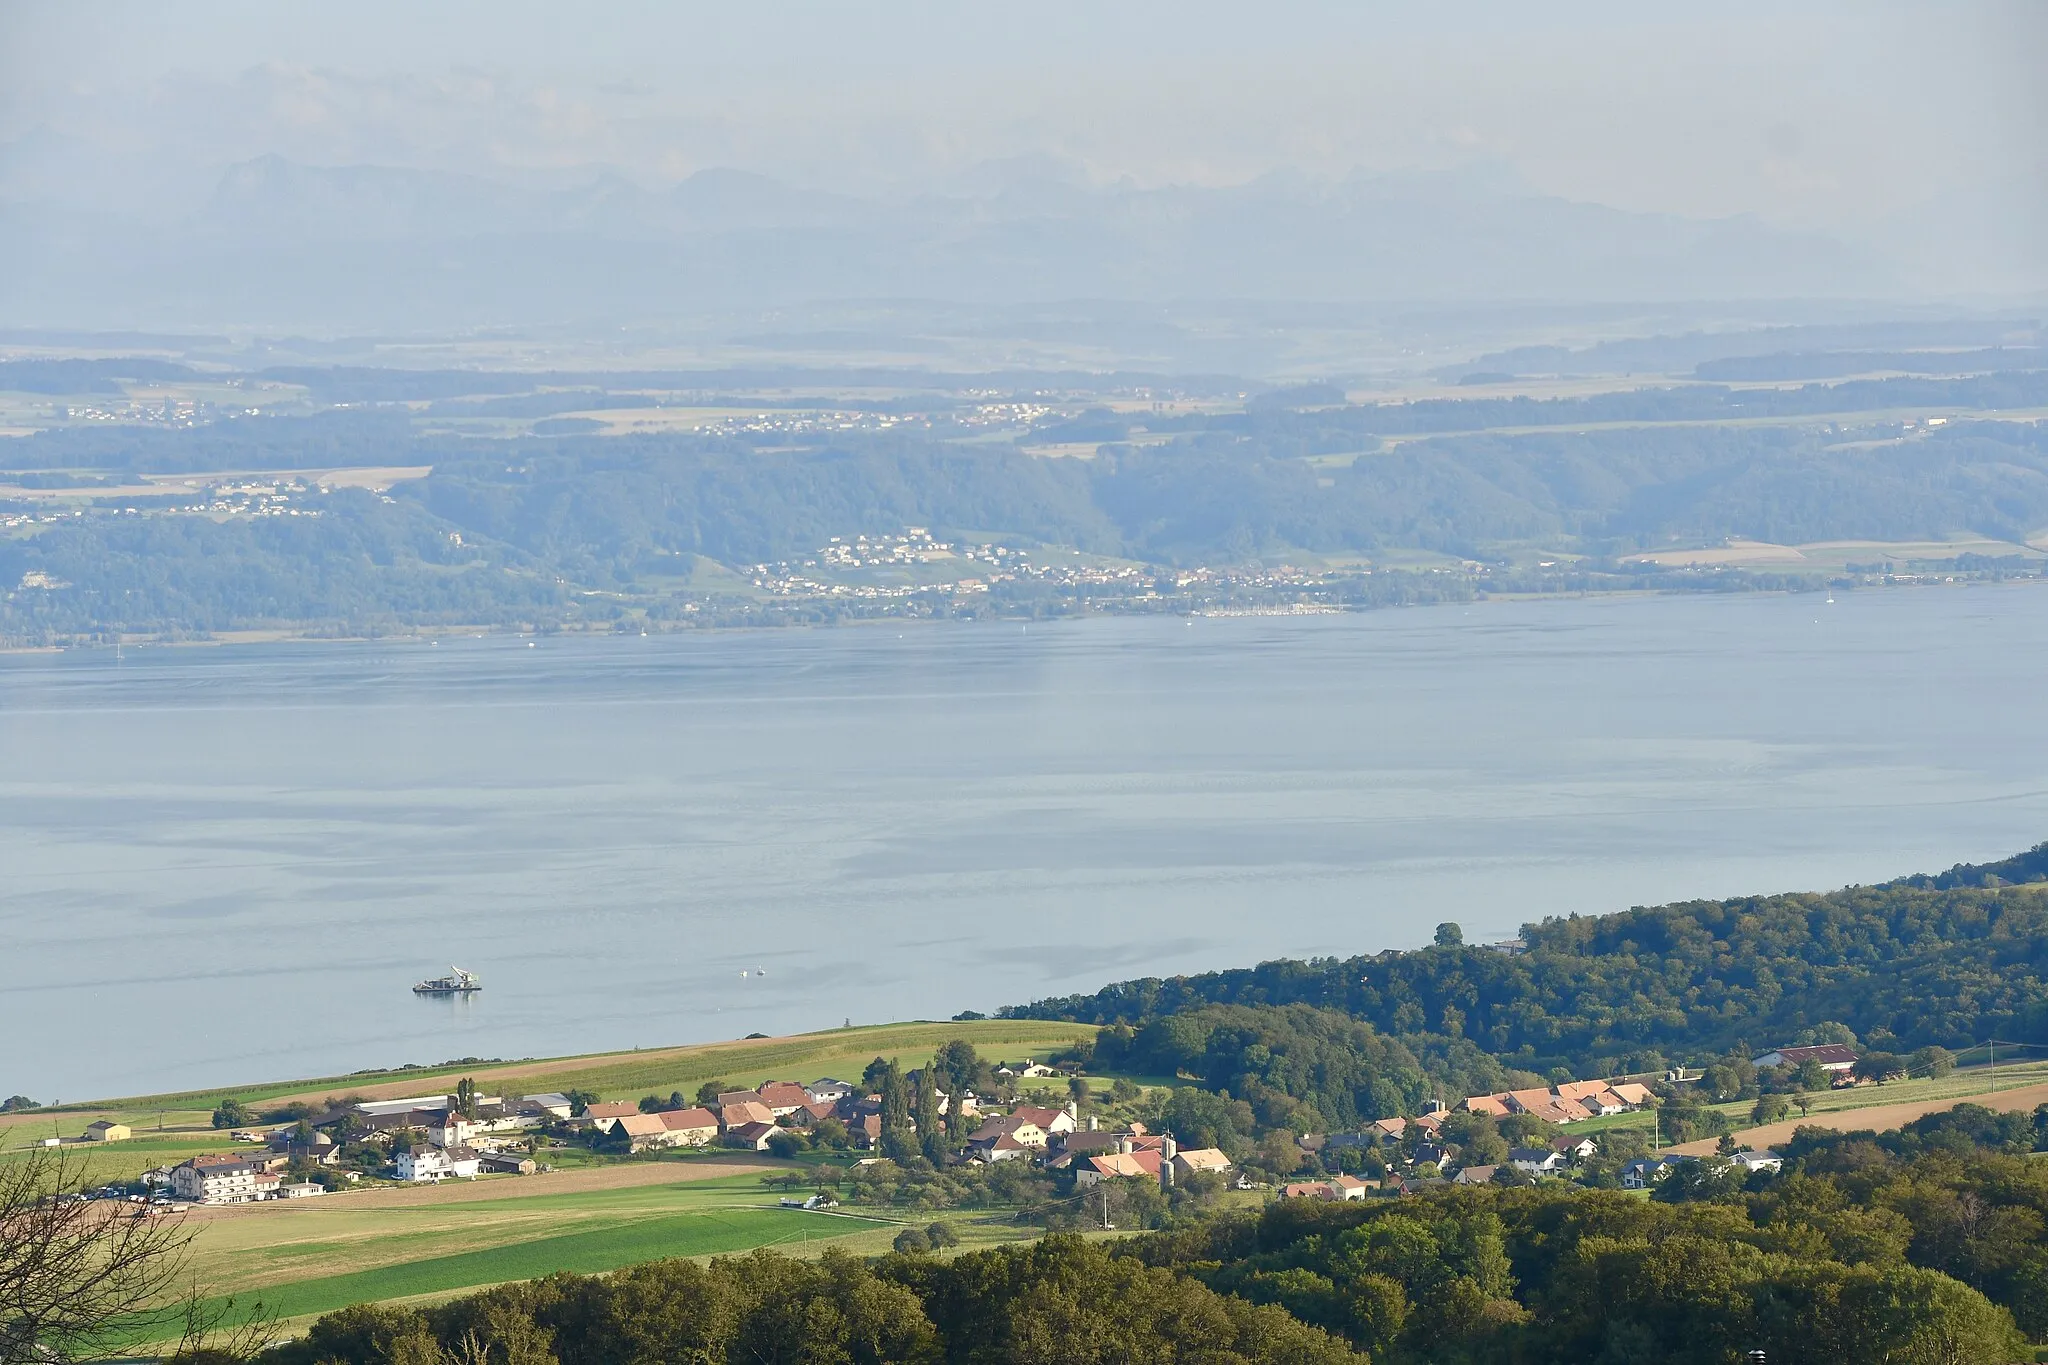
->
xmin=43 ymin=1044 xmax=1858 ymax=1205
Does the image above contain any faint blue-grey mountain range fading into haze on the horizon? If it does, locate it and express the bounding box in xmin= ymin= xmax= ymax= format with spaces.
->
xmin=0 ymin=156 xmax=1894 ymax=329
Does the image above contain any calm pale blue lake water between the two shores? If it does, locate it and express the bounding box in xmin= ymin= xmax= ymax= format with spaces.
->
xmin=0 ymin=587 xmax=2048 ymax=1101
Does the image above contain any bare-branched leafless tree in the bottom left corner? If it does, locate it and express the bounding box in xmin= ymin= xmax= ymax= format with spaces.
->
xmin=0 ymin=1148 xmax=193 ymax=1365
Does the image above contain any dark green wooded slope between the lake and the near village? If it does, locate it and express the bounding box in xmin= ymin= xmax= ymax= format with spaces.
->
xmin=1004 ymin=845 xmax=2048 ymax=1080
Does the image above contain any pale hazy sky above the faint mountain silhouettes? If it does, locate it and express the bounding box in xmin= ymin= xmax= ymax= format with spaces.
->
xmin=0 ymin=0 xmax=2048 ymax=300
